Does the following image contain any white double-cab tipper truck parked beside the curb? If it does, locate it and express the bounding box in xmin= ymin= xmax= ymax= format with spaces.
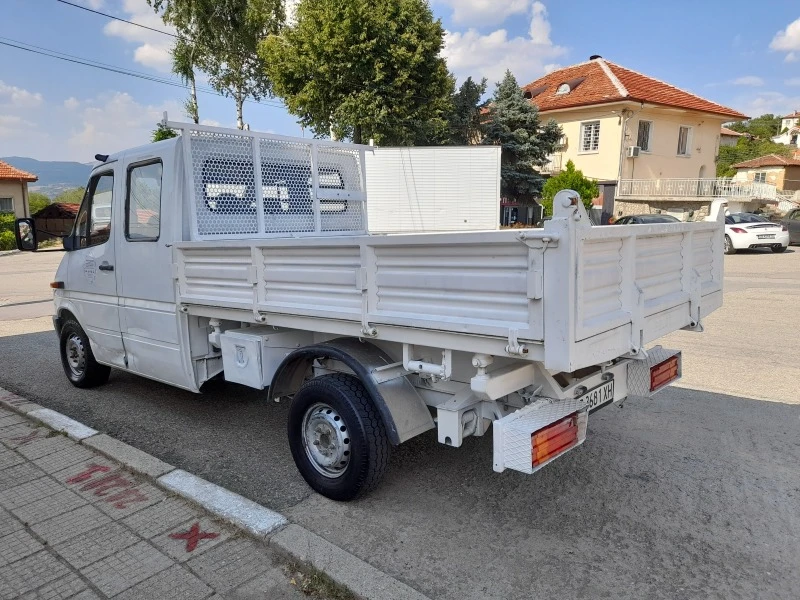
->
xmin=17 ymin=122 xmax=724 ymax=500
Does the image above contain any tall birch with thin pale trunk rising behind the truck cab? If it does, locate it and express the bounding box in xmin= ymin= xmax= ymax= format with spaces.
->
xmin=147 ymin=0 xmax=285 ymax=129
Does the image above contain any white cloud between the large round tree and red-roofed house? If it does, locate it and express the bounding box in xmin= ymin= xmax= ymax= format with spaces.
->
xmin=442 ymin=2 xmax=567 ymax=85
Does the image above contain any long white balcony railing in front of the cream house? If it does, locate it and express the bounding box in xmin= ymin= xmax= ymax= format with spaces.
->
xmin=617 ymin=179 xmax=777 ymax=200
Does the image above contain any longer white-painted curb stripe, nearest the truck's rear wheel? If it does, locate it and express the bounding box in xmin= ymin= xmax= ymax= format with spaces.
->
xmin=156 ymin=469 xmax=288 ymax=536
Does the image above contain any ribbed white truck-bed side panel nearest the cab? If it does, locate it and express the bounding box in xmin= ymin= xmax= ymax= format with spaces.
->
xmin=179 ymin=247 xmax=254 ymax=305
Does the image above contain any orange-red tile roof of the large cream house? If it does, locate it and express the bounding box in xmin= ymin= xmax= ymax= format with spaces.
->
xmin=523 ymin=58 xmax=747 ymax=119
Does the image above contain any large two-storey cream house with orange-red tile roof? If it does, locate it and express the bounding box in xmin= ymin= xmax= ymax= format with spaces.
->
xmin=523 ymin=56 xmax=764 ymax=218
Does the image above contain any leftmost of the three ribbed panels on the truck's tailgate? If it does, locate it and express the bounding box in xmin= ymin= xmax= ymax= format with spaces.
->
xmin=577 ymin=238 xmax=622 ymax=330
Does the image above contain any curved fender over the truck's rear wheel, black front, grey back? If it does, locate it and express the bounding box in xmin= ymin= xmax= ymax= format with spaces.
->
xmin=269 ymin=338 xmax=434 ymax=446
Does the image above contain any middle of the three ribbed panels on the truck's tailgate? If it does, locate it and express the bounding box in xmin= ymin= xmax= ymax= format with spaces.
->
xmin=636 ymin=233 xmax=688 ymax=314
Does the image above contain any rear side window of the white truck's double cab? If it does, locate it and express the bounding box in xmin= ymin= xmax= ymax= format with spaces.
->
xmin=125 ymin=161 xmax=163 ymax=242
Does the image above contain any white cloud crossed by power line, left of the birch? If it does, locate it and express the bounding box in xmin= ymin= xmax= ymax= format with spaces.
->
xmin=103 ymin=0 xmax=175 ymax=73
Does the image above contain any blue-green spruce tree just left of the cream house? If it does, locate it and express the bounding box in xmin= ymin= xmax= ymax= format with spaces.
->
xmin=482 ymin=71 xmax=561 ymax=201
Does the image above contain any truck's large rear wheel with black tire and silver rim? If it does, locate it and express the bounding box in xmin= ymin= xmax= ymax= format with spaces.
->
xmin=288 ymin=373 xmax=391 ymax=501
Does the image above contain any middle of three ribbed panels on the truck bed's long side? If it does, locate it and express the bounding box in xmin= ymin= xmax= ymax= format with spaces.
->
xmin=263 ymin=244 xmax=361 ymax=319
